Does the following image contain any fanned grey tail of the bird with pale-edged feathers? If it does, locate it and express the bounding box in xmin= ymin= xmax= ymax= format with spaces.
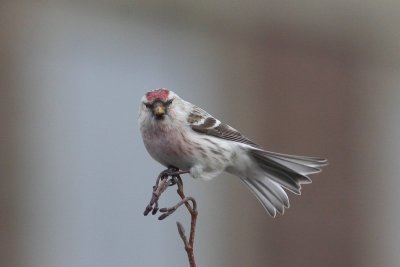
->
xmin=241 ymin=149 xmax=327 ymax=217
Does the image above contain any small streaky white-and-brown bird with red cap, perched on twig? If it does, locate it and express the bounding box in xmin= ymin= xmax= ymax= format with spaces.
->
xmin=139 ymin=88 xmax=327 ymax=217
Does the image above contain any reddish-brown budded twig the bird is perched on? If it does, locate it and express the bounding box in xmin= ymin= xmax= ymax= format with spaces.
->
xmin=144 ymin=167 xmax=198 ymax=267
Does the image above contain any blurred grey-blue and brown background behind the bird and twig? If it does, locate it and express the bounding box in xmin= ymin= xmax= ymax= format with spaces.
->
xmin=0 ymin=0 xmax=400 ymax=267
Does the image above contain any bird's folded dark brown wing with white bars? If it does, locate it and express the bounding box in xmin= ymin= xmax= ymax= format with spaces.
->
xmin=188 ymin=107 xmax=260 ymax=148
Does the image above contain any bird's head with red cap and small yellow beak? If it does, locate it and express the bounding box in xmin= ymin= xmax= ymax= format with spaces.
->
xmin=141 ymin=88 xmax=177 ymax=120
